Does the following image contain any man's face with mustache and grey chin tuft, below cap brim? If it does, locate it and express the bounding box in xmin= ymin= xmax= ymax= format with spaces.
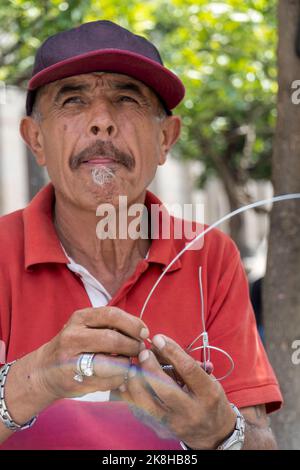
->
xmin=21 ymin=73 xmax=180 ymax=211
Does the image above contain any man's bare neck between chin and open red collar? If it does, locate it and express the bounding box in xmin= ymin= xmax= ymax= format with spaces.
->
xmin=54 ymin=191 xmax=151 ymax=295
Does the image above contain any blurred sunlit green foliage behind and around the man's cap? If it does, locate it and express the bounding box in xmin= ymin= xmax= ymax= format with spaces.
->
xmin=0 ymin=0 xmax=277 ymax=193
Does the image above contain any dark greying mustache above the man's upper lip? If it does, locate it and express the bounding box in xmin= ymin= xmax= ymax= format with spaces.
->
xmin=70 ymin=140 xmax=135 ymax=170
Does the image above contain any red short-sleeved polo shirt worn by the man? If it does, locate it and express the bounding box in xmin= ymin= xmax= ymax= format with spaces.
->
xmin=0 ymin=184 xmax=282 ymax=449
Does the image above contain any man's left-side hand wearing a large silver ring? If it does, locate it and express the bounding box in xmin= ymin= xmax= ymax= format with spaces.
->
xmin=0 ymin=307 xmax=149 ymax=443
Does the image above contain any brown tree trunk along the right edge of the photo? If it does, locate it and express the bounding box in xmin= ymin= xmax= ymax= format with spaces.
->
xmin=264 ymin=0 xmax=300 ymax=449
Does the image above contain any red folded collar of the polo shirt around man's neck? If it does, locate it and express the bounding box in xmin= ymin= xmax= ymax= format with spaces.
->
xmin=23 ymin=183 xmax=181 ymax=272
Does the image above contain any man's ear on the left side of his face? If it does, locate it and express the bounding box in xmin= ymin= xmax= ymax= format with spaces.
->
xmin=20 ymin=116 xmax=46 ymax=166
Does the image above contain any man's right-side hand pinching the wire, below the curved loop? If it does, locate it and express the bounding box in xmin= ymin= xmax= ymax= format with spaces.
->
xmin=121 ymin=335 xmax=236 ymax=449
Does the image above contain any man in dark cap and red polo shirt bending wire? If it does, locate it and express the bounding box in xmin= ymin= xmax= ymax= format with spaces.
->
xmin=0 ymin=21 xmax=281 ymax=450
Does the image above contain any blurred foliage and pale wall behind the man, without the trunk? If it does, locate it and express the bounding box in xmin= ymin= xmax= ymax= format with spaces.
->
xmin=0 ymin=0 xmax=277 ymax=278
